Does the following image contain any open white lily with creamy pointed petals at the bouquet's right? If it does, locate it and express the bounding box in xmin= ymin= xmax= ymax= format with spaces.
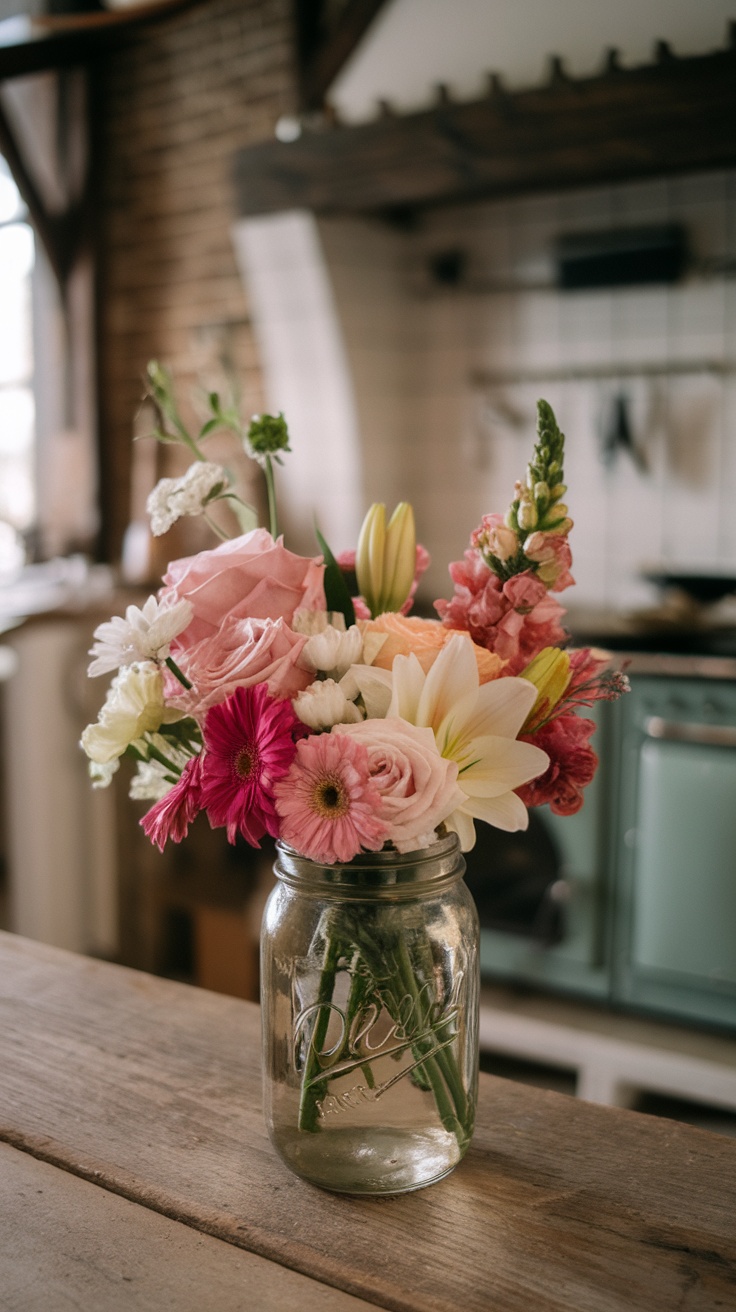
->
xmin=388 ymin=634 xmax=548 ymax=851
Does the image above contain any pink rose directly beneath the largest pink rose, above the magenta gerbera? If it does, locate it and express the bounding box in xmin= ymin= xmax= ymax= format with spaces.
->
xmin=165 ymin=614 xmax=315 ymax=715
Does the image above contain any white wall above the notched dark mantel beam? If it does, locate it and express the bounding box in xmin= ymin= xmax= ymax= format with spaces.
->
xmin=329 ymin=0 xmax=736 ymax=122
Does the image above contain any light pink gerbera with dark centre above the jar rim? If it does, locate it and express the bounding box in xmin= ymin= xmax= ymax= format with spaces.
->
xmin=274 ymin=733 xmax=387 ymax=865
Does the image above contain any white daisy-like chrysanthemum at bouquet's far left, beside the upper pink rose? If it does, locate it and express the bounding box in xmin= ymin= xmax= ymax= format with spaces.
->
xmin=87 ymin=597 xmax=194 ymax=677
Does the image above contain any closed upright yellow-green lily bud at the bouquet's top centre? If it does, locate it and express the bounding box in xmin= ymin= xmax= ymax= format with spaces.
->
xmin=356 ymin=501 xmax=416 ymax=618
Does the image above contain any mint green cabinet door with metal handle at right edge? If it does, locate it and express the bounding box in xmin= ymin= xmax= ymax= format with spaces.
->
xmin=613 ymin=678 xmax=736 ymax=1026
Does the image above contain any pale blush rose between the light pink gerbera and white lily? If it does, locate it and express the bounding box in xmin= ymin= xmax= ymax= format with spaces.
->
xmin=332 ymin=718 xmax=466 ymax=851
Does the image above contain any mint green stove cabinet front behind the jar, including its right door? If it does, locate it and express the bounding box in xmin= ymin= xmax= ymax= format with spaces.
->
xmin=472 ymin=674 xmax=736 ymax=1029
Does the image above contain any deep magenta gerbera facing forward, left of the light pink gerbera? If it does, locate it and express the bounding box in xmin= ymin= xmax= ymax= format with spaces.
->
xmin=202 ymin=684 xmax=300 ymax=848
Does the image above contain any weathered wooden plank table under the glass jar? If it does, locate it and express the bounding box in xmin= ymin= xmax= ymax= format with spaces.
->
xmin=0 ymin=934 xmax=736 ymax=1312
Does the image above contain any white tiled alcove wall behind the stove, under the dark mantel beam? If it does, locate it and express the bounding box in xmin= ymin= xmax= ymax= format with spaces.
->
xmin=233 ymin=172 xmax=736 ymax=609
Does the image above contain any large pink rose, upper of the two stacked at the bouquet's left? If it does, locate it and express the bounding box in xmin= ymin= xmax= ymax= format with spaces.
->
xmin=159 ymin=529 xmax=325 ymax=650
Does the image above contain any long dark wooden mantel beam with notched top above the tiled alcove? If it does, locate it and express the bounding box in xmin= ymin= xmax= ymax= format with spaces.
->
xmin=235 ymin=43 xmax=736 ymax=215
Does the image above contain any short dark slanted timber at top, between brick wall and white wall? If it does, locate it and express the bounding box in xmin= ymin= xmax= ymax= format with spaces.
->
xmin=295 ymin=0 xmax=386 ymax=110
